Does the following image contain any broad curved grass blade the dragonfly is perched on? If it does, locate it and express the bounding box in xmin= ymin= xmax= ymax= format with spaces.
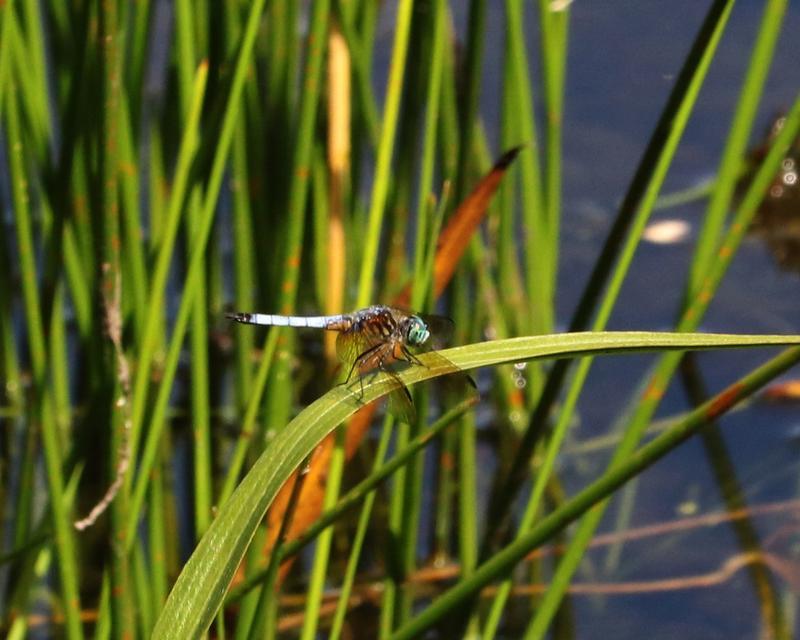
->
xmin=153 ymin=332 xmax=800 ymax=639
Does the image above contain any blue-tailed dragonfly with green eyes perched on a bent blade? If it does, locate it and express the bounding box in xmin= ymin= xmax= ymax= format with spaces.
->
xmin=227 ymin=305 xmax=475 ymax=422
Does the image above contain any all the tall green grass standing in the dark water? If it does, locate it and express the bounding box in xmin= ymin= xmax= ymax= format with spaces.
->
xmin=0 ymin=0 xmax=800 ymax=639
